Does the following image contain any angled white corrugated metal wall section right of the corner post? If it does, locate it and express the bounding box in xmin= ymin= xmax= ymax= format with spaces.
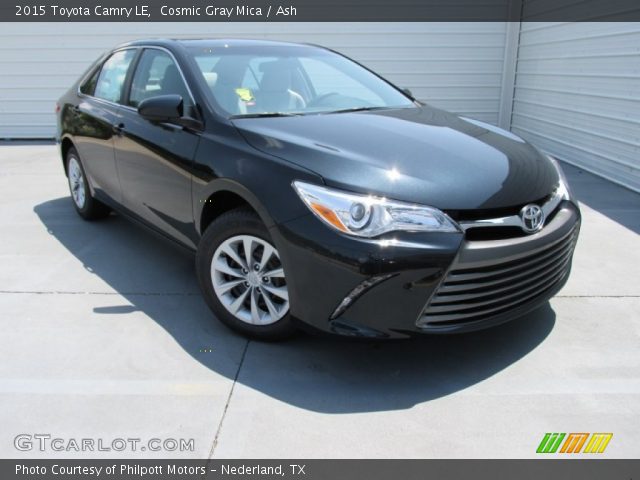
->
xmin=511 ymin=22 xmax=640 ymax=190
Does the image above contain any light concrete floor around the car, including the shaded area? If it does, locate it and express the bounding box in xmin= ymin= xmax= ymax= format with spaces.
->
xmin=0 ymin=145 xmax=640 ymax=458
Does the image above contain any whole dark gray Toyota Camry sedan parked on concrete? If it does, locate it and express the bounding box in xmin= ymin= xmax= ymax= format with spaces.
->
xmin=58 ymin=40 xmax=580 ymax=339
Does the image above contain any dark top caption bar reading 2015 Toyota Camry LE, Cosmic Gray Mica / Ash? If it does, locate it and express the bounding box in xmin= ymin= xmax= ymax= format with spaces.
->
xmin=0 ymin=0 xmax=640 ymax=22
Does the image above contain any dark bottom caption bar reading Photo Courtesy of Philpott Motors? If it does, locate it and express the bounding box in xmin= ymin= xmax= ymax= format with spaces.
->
xmin=0 ymin=458 xmax=640 ymax=480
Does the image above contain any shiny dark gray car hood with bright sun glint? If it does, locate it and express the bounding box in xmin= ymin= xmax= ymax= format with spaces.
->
xmin=233 ymin=106 xmax=559 ymax=210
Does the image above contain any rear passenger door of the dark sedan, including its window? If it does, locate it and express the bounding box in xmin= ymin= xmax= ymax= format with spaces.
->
xmin=71 ymin=48 xmax=137 ymax=203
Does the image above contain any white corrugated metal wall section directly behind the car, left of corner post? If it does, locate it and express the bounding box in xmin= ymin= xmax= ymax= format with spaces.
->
xmin=0 ymin=22 xmax=506 ymax=138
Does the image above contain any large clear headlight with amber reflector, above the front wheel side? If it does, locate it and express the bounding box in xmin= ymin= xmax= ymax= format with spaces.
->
xmin=293 ymin=180 xmax=459 ymax=238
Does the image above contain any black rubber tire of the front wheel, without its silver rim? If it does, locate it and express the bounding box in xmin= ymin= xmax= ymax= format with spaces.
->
xmin=196 ymin=208 xmax=297 ymax=341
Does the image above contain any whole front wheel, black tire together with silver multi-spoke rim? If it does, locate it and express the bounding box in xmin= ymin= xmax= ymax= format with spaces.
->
xmin=196 ymin=208 xmax=297 ymax=341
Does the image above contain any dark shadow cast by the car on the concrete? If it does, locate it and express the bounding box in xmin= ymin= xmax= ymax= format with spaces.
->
xmin=34 ymin=197 xmax=555 ymax=413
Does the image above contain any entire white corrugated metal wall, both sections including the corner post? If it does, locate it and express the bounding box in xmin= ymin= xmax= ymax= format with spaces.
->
xmin=0 ymin=22 xmax=640 ymax=190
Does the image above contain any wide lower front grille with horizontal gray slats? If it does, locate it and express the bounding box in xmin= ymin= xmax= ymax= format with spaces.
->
xmin=417 ymin=228 xmax=578 ymax=328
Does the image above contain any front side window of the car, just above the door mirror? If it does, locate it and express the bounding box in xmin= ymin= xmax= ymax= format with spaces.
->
xmin=129 ymin=48 xmax=193 ymax=115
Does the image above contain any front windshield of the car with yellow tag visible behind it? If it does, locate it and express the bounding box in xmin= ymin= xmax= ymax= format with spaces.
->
xmin=188 ymin=45 xmax=414 ymax=118
